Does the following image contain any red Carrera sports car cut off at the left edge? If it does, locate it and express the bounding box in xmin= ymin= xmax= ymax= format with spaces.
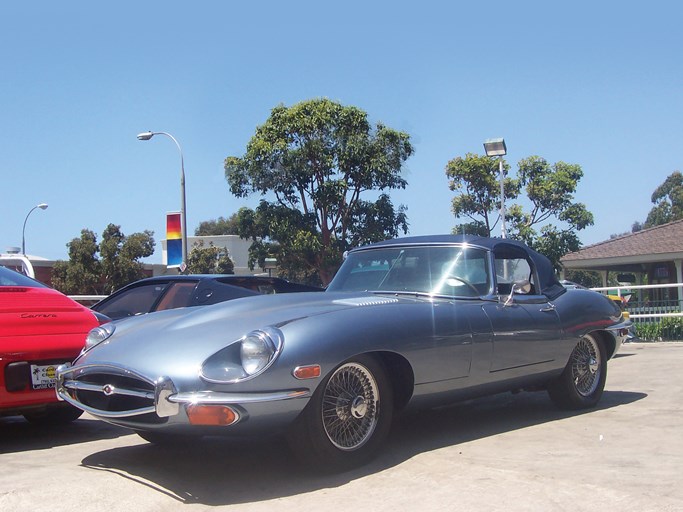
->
xmin=0 ymin=266 xmax=108 ymax=424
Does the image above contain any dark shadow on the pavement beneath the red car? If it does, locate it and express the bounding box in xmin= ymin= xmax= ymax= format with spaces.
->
xmin=0 ymin=416 xmax=131 ymax=453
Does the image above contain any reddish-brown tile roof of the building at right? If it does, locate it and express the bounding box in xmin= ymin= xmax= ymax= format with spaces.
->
xmin=560 ymin=220 xmax=683 ymax=262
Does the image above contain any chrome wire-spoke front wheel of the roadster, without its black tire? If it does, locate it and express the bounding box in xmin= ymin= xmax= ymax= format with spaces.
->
xmin=321 ymin=362 xmax=380 ymax=451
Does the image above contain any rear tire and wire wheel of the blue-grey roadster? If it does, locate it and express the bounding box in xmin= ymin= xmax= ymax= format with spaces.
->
xmin=548 ymin=334 xmax=607 ymax=410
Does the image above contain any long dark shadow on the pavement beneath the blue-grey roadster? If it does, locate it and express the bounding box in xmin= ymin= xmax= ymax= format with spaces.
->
xmin=82 ymin=391 xmax=647 ymax=506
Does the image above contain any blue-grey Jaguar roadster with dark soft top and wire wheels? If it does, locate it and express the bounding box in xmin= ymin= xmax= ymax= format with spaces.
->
xmin=57 ymin=235 xmax=630 ymax=469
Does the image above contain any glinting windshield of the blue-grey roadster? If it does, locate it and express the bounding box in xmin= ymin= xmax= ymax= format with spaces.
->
xmin=327 ymin=246 xmax=491 ymax=297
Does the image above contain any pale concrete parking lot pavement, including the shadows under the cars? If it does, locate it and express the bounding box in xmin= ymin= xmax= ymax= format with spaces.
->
xmin=0 ymin=342 xmax=683 ymax=512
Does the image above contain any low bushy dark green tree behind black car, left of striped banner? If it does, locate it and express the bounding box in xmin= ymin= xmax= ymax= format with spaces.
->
xmin=52 ymin=224 xmax=155 ymax=295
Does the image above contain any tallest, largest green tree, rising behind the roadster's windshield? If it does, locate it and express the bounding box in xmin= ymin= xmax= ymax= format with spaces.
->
xmin=225 ymin=99 xmax=413 ymax=284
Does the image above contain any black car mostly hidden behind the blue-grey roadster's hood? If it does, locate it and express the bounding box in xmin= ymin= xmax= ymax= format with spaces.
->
xmin=92 ymin=274 xmax=323 ymax=320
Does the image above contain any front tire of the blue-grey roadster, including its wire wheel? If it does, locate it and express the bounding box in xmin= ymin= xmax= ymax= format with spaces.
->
xmin=287 ymin=356 xmax=393 ymax=472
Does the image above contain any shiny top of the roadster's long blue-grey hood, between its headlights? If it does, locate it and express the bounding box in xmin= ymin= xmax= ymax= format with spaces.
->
xmin=76 ymin=292 xmax=406 ymax=377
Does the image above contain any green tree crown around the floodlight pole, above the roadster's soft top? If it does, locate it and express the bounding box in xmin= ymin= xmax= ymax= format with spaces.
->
xmin=446 ymin=153 xmax=593 ymax=268
